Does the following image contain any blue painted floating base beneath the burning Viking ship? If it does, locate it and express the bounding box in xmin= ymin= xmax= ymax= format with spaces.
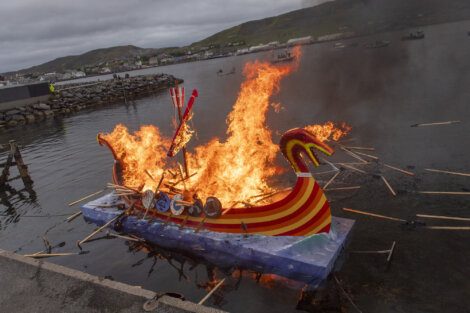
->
xmin=82 ymin=193 xmax=354 ymax=286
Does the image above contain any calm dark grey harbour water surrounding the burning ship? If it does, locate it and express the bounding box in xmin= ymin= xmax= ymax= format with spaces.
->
xmin=0 ymin=22 xmax=470 ymax=312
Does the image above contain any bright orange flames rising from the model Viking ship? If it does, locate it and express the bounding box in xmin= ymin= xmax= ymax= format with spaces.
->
xmin=103 ymin=47 xmax=348 ymax=205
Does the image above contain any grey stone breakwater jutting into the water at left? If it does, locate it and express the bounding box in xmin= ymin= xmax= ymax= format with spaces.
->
xmin=0 ymin=74 xmax=183 ymax=128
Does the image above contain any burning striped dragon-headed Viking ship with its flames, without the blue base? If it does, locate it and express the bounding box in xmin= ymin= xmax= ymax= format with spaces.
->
xmin=94 ymin=49 xmax=348 ymax=236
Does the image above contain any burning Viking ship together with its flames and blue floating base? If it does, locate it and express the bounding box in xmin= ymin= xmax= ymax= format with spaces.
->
xmin=82 ymin=49 xmax=354 ymax=286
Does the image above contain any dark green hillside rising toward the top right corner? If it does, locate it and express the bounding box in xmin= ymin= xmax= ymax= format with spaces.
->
xmin=191 ymin=0 xmax=470 ymax=47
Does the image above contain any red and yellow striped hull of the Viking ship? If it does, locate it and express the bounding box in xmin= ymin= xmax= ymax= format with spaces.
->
xmin=125 ymin=173 xmax=331 ymax=236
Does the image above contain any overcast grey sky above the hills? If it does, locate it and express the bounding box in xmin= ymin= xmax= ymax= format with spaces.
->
xmin=0 ymin=0 xmax=325 ymax=73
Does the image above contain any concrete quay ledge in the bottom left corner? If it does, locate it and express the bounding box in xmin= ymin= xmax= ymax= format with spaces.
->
xmin=0 ymin=249 xmax=223 ymax=313
